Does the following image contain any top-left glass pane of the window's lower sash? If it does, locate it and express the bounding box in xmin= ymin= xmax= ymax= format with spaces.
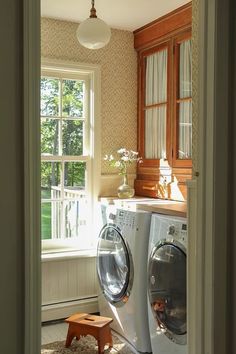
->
xmin=41 ymin=162 xmax=61 ymax=199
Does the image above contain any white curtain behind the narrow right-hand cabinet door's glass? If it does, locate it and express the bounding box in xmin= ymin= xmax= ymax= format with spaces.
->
xmin=178 ymin=39 xmax=192 ymax=159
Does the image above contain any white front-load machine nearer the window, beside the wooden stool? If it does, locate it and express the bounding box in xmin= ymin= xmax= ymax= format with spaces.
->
xmin=97 ymin=209 xmax=151 ymax=352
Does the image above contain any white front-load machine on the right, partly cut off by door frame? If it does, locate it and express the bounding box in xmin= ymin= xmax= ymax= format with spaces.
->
xmin=148 ymin=214 xmax=187 ymax=354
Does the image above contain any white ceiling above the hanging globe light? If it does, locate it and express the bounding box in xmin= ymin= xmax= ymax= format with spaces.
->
xmin=41 ymin=0 xmax=189 ymax=31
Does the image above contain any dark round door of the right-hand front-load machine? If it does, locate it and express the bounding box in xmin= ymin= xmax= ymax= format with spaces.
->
xmin=148 ymin=242 xmax=186 ymax=344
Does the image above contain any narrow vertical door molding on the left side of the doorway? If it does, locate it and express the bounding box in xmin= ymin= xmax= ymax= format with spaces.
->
xmin=23 ymin=0 xmax=41 ymax=354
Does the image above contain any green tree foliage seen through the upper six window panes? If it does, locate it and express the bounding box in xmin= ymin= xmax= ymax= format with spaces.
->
xmin=41 ymin=77 xmax=85 ymax=189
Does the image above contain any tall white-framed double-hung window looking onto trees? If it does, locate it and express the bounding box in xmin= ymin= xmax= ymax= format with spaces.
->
xmin=41 ymin=61 xmax=99 ymax=251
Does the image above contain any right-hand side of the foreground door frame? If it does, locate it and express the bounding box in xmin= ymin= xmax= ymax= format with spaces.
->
xmin=188 ymin=0 xmax=230 ymax=354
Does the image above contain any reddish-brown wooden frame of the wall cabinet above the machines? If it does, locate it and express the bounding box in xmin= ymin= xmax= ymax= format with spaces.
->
xmin=134 ymin=3 xmax=192 ymax=200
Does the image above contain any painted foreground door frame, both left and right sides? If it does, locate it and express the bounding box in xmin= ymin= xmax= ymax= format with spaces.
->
xmin=23 ymin=0 xmax=233 ymax=354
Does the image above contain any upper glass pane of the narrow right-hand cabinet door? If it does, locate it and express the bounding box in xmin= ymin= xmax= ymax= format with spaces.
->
xmin=179 ymin=39 xmax=192 ymax=98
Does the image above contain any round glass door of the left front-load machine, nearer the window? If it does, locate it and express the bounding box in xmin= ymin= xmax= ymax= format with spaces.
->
xmin=97 ymin=224 xmax=132 ymax=304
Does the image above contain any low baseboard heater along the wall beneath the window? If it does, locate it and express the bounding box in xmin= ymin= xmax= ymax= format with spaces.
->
xmin=41 ymin=296 xmax=98 ymax=322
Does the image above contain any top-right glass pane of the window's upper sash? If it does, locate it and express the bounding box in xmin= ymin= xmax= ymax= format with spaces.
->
xmin=62 ymin=80 xmax=84 ymax=117
